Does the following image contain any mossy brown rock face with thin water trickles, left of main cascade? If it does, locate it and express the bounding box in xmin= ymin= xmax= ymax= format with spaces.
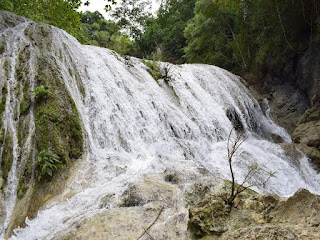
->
xmin=0 ymin=11 xmax=84 ymax=236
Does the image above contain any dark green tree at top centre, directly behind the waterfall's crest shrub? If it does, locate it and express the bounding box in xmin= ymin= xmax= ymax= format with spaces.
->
xmin=138 ymin=0 xmax=196 ymax=63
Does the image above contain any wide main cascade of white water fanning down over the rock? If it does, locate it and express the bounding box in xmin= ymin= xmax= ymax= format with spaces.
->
xmin=0 ymin=15 xmax=320 ymax=239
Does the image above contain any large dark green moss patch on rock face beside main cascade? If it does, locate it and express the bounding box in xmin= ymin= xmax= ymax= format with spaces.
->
xmin=35 ymin=55 xmax=83 ymax=177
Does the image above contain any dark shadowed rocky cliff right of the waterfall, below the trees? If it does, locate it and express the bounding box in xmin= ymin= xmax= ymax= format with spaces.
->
xmin=248 ymin=43 xmax=320 ymax=168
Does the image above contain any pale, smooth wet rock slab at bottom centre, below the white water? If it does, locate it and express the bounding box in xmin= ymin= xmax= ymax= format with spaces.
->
xmin=55 ymin=166 xmax=223 ymax=240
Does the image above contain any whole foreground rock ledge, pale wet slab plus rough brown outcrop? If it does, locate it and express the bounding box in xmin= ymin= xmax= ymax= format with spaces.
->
xmin=55 ymin=166 xmax=320 ymax=240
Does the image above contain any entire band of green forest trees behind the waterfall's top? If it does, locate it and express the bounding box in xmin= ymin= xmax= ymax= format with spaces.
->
xmin=0 ymin=0 xmax=320 ymax=80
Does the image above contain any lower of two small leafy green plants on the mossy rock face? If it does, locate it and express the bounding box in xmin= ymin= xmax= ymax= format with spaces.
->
xmin=38 ymin=150 xmax=61 ymax=180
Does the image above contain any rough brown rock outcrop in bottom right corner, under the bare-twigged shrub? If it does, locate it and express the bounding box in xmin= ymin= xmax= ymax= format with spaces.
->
xmin=188 ymin=189 xmax=320 ymax=240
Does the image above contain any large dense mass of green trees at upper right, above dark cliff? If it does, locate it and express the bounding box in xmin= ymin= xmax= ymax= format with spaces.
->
xmin=185 ymin=0 xmax=320 ymax=73
